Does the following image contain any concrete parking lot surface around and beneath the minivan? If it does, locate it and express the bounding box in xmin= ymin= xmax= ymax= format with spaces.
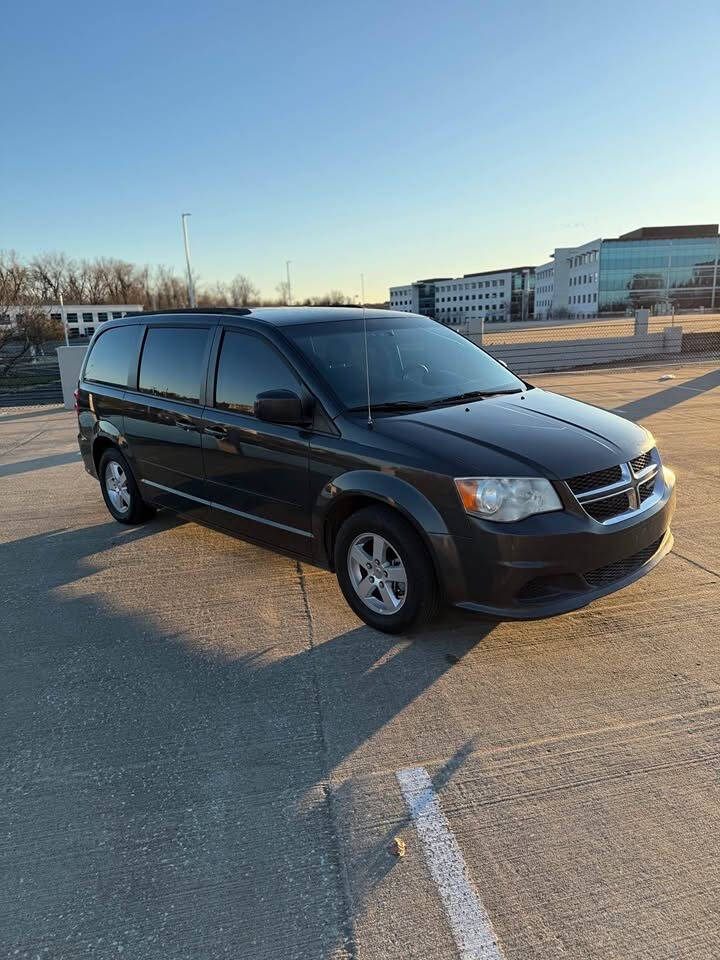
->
xmin=0 ymin=365 xmax=720 ymax=960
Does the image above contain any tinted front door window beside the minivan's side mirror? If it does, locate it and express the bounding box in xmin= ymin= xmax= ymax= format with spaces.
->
xmin=215 ymin=330 xmax=302 ymax=416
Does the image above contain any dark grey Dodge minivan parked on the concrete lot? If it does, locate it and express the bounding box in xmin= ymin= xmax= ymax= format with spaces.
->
xmin=76 ymin=307 xmax=675 ymax=632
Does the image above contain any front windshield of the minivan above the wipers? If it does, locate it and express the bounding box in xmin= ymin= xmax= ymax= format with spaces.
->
xmin=283 ymin=311 xmax=525 ymax=409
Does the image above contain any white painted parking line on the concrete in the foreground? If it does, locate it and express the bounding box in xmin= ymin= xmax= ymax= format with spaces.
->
xmin=395 ymin=767 xmax=504 ymax=960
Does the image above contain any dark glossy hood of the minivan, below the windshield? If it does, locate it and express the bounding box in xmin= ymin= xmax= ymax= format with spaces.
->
xmin=376 ymin=388 xmax=654 ymax=479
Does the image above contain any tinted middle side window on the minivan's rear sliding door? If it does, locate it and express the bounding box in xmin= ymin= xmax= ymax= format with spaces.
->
xmin=138 ymin=327 xmax=209 ymax=403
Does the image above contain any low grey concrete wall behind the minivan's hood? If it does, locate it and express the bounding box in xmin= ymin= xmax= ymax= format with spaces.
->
xmin=469 ymin=326 xmax=682 ymax=373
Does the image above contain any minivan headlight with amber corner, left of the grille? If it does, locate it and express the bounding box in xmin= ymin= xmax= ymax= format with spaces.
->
xmin=455 ymin=477 xmax=562 ymax=523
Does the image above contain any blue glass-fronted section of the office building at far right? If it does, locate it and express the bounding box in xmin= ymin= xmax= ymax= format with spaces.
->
xmin=598 ymin=225 xmax=720 ymax=313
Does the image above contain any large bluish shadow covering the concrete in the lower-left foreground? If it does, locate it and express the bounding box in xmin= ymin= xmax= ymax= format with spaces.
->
xmin=0 ymin=514 xmax=493 ymax=960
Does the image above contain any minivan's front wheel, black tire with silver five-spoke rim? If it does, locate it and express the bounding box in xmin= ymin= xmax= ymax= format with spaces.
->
xmin=335 ymin=506 xmax=440 ymax=633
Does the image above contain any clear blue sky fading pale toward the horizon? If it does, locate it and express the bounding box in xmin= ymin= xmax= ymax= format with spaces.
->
xmin=5 ymin=0 xmax=720 ymax=299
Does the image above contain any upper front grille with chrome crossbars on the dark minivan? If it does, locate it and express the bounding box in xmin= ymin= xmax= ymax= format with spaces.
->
xmin=565 ymin=447 xmax=661 ymax=523
